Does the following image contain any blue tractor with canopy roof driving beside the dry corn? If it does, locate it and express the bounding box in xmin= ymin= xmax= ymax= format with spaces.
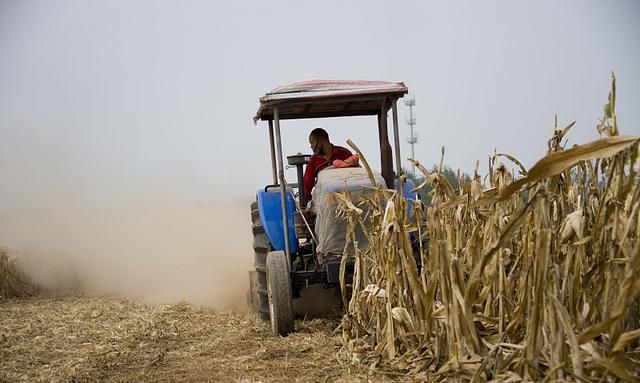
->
xmin=249 ymin=80 xmax=416 ymax=336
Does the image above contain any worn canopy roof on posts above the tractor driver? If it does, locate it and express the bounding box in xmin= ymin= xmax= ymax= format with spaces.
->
xmin=253 ymin=80 xmax=407 ymax=123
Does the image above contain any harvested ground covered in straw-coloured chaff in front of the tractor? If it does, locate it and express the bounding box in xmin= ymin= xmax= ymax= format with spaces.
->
xmin=0 ymin=296 xmax=404 ymax=382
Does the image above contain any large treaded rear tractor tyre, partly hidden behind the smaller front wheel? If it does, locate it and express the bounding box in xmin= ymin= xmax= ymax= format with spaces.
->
xmin=251 ymin=201 xmax=271 ymax=320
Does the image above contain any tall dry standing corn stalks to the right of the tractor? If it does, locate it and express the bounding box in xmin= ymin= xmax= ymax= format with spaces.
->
xmin=339 ymin=77 xmax=640 ymax=382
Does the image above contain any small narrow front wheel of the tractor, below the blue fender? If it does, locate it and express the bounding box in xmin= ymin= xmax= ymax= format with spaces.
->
xmin=267 ymin=250 xmax=293 ymax=336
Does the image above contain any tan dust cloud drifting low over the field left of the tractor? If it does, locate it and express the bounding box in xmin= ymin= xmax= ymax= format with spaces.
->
xmin=0 ymin=185 xmax=252 ymax=309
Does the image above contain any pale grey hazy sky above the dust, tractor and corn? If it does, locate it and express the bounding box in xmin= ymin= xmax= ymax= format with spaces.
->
xmin=0 ymin=0 xmax=640 ymax=207
